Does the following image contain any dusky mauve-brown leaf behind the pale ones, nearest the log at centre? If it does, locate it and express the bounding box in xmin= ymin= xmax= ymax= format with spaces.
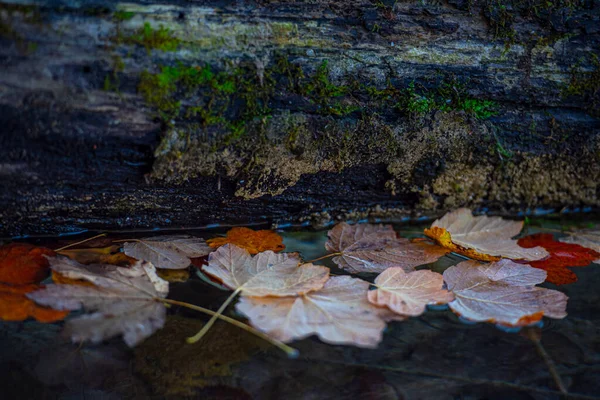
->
xmin=325 ymin=222 xmax=449 ymax=273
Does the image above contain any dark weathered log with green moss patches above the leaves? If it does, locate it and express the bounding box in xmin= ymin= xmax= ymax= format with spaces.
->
xmin=0 ymin=0 xmax=600 ymax=235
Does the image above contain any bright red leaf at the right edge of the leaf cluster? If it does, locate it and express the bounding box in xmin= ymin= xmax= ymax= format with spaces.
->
xmin=517 ymin=233 xmax=600 ymax=285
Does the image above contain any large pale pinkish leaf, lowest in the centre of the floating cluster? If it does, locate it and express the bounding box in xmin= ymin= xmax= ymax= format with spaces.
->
xmin=236 ymin=276 xmax=386 ymax=348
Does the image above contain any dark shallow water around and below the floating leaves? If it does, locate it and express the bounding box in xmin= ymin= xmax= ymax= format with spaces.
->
xmin=0 ymin=215 xmax=600 ymax=400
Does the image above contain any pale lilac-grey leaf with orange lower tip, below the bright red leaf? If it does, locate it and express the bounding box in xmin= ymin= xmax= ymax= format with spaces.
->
xmin=444 ymin=259 xmax=568 ymax=326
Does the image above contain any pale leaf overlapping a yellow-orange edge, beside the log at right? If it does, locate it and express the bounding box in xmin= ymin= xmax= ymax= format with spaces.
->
xmin=425 ymin=208 xmax=548 ymax=261
